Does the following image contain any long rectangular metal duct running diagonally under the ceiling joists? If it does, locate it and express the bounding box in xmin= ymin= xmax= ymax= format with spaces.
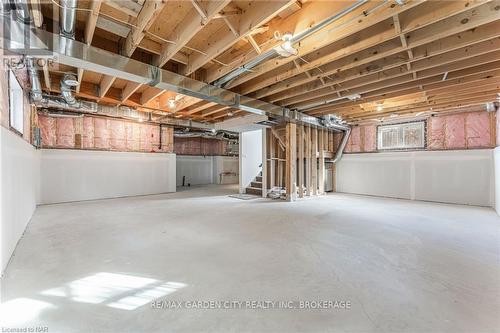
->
xmin=2 ymin=17 xmax=347 ymax=131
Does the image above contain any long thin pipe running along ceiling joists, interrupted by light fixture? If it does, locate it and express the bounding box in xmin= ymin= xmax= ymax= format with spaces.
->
xmin=213 ymin=0 xmax=368 ymax=88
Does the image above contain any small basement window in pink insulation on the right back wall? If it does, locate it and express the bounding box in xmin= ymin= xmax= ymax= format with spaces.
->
xmin=377 ymin=121 xmax=425 ymax=150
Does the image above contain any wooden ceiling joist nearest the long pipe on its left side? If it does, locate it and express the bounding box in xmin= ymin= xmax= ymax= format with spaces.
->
xmin=183 ymin=0 xmax=293 ymax=75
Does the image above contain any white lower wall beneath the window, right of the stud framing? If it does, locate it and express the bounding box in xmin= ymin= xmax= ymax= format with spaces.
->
xmin=336 ymin=149 xmax=494 ymax=206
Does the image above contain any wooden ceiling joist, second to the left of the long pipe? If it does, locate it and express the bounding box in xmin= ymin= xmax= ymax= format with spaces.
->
xmin=155 ymin=0 xmax=231 ymax=67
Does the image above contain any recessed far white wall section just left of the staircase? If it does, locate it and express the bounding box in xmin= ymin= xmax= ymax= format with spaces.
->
xmin=176 ymin=155 xmax=238 ymax=186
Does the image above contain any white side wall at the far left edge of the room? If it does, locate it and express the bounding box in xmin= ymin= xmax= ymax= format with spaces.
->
xmin=0 ymin=126 xmax=40 ymax=274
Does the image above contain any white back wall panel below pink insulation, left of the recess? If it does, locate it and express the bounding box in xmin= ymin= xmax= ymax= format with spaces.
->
xmin=41 ymin=149 xmax=175 ymax=204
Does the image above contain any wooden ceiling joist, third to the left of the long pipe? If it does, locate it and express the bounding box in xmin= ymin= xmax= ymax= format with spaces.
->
xmin=123 ymin=0 xmax=165 ymax=57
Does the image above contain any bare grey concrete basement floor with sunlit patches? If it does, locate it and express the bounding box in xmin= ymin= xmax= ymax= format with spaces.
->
xmin=2 ymin=186 xmax=500 ymax=332
